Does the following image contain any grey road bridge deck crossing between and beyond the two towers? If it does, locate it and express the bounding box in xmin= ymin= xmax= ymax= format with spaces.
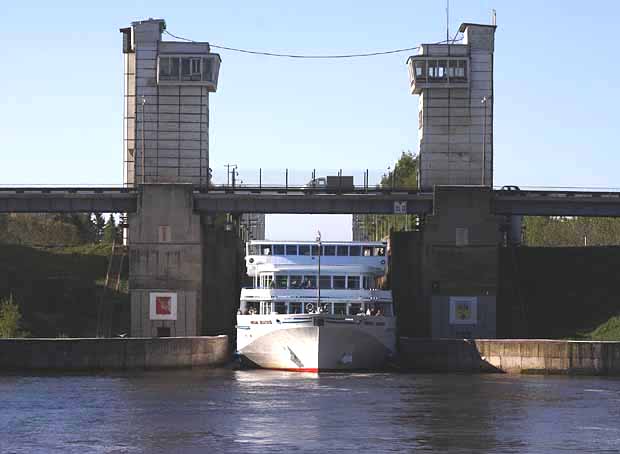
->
xmin=0 ymin=186 xmax=620 ymax=217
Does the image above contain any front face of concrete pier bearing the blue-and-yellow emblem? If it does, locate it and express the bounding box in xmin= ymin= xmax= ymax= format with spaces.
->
xmin=421 ymin=186 xmax=503 ymax=338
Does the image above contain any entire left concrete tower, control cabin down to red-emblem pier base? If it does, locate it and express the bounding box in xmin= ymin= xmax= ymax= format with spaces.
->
xmin=121 ymin=19 xmax=220 ymax=337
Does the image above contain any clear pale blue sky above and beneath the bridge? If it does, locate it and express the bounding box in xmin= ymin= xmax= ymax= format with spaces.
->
xmin=0 ymin=0 xmax=620 ymax=239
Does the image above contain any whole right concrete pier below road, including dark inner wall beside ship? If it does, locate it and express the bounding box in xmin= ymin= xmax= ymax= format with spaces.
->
xmin=392 ymin=186 xmax=504 ymax=339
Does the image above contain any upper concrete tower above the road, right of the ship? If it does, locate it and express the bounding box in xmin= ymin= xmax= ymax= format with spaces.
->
xmin=407 ymin=23 xmax=496 ymax=191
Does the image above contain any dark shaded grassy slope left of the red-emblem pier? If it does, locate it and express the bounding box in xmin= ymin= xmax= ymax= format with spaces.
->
xmin=0 ymin=244 xmax=127 ymax=337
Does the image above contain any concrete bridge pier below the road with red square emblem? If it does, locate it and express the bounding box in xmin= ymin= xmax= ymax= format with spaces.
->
xmin=129 ymin=184 xmax=204 ymax=337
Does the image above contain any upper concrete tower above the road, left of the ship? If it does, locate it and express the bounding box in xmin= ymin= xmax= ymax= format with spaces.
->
xmin=121 ymin=19 xmax=220 ymax=186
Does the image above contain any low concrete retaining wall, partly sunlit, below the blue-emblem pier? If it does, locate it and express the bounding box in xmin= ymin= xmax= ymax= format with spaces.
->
xmin=399 ymin=338 xmax=620 ymax=375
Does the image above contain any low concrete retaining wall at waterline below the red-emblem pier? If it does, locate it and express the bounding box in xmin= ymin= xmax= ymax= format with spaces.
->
xmin=0 ymin=336 xmax=230 ymax=372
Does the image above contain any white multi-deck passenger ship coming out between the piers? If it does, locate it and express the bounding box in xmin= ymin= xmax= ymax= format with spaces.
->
xmin=237 ymin=241 xmax=396 ymax=372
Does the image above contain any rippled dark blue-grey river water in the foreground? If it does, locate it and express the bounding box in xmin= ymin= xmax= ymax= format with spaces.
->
xmin=0 ymin=369 xmax=620 ymax=454
